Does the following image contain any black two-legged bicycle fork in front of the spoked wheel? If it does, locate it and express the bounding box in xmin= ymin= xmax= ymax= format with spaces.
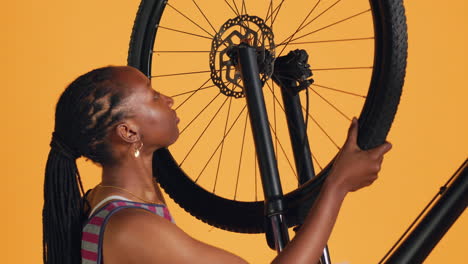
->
xmin=238 ymin=43 xmax=331 ymax=264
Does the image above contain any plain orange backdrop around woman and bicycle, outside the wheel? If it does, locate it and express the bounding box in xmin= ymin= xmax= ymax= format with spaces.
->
xmin=0 ymin=0 xmax=468 ymax=263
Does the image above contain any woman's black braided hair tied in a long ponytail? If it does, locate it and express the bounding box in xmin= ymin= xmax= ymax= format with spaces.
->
xmin=42 ymin=66 xmax=133 ymax=264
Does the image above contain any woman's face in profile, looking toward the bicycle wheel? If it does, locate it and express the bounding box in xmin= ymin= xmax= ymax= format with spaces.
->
xmin=117 ymin=67 xmax=179 ymax=149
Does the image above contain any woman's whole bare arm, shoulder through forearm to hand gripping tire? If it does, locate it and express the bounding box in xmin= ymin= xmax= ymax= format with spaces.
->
xmin=104 ymin=118 xmax=391 ymax=264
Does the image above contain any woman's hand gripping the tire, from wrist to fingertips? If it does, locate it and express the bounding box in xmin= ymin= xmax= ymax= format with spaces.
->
xmin=326 ymin=118 xmax=392 ymax=193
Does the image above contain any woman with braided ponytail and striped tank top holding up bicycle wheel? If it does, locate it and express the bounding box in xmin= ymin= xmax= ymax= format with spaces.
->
xmin=43 ymin=67 xmax=391 ymax=264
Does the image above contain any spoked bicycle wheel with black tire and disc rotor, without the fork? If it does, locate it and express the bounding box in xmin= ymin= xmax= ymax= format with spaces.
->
xmin=128 ymin=0 xmax=407 ymax=233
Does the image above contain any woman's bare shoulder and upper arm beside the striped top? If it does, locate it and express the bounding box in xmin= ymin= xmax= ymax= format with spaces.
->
xmin=104 ymin=209 xmax=246 ymax=264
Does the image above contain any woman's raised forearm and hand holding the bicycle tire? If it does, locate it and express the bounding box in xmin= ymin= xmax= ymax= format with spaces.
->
xmin=273 ymin=119 xmax=391 ymax=264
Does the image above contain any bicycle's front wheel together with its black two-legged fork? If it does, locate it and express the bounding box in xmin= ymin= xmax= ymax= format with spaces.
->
xmin=128 ymin=0 xmax=407 ymax=262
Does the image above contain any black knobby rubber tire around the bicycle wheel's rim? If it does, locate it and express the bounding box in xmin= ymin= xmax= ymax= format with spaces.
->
xmin=128 ymin=0 xmax=407 ymax=233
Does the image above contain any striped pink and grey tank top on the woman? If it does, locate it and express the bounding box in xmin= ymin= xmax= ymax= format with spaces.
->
xmin=81 ymin=195 xmax=174 ymax=264
